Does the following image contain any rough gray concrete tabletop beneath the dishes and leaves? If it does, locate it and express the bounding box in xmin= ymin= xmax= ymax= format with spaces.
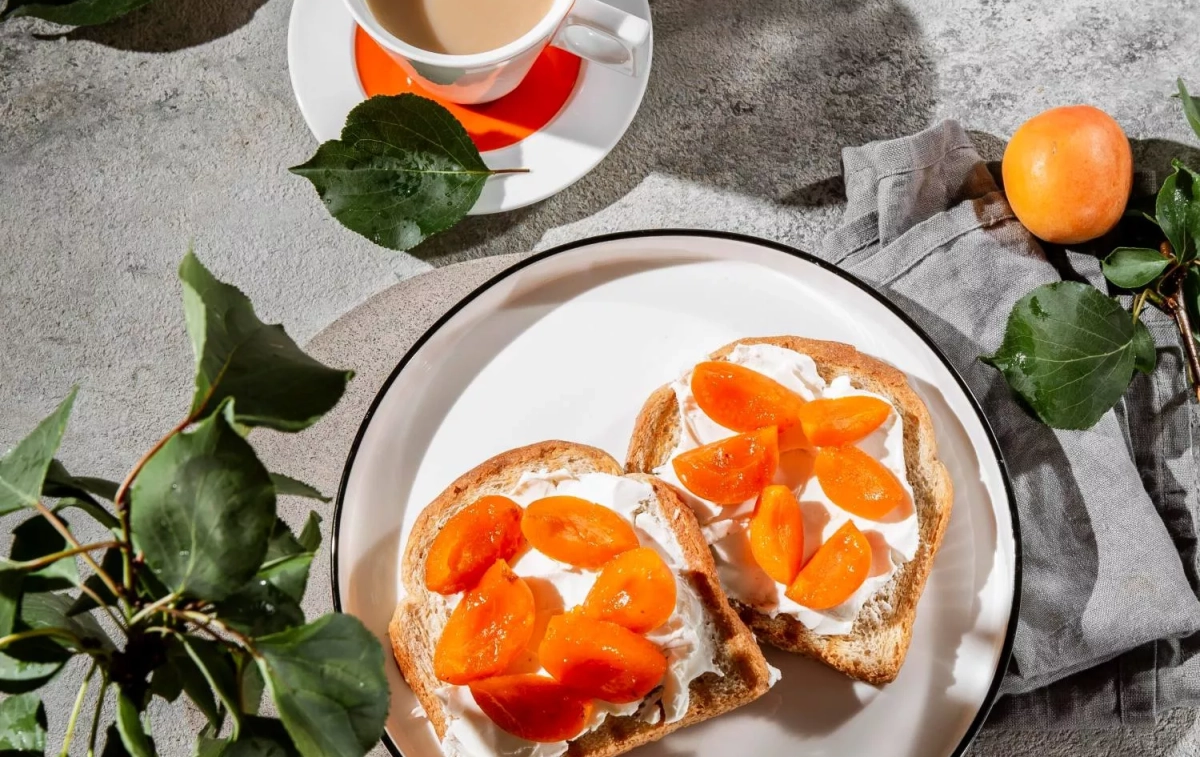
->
xmin=0 ymin=0 xmax=1200 ymax=757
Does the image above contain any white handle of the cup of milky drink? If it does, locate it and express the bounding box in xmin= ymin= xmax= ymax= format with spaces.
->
xmin=550 ymin=0 xmax=650 ymax=76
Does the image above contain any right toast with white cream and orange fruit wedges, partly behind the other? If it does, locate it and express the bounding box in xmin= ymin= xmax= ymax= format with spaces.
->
xmin=625 ymin=336 xmax=953 ymax=684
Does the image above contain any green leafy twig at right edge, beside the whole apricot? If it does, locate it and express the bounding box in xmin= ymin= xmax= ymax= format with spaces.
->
xmin=983 ymin=79 xmax=1200 ymax=428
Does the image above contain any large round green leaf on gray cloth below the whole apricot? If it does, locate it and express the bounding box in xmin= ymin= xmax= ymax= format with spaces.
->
xmin=984 ymin=282 xmax=1136 ymax=428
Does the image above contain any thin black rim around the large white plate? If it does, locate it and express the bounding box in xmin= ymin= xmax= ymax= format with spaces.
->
xmin=330 ymin=229 xmax=1022 ymax=757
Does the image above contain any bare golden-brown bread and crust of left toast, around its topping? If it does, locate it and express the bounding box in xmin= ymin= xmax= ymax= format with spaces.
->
xmin=388 ymin=441 xmax=772 ymax=757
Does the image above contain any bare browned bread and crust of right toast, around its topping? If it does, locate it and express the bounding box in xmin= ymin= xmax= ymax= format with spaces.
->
xmin=625 ymin=336 xmax=954 ymax=684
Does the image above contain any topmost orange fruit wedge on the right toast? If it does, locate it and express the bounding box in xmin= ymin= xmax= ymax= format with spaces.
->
xmin=691 ymin=360 xmax=808 ymax=451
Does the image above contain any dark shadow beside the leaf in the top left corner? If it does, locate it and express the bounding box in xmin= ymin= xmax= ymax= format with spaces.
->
xmin=42 ymin=0 xmax=267 ymax=53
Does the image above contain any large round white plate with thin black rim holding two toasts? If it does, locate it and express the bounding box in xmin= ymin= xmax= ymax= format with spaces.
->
xmin=332 ymin=232 xmax=1020 ymax=757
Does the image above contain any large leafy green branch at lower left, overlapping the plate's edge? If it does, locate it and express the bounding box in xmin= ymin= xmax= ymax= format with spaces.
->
xmin=0 ymin=253 xmax=388 ymax=757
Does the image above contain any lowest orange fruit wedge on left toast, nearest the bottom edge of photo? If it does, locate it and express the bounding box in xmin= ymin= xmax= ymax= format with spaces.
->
xmin=470 ymin=673 xmax=592 ymax=741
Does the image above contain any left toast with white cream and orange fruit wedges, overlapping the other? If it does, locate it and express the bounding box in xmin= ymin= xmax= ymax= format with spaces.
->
xmin=389 ymin=441 xmax=775 ymax=757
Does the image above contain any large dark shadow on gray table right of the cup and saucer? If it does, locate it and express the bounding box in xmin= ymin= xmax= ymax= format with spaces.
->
xmin=414 ymin=0 xmax=935 ymax=265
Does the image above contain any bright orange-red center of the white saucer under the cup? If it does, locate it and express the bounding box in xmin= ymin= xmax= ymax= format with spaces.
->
xmin=354 ymin=28 xmax=580 ymax=151
